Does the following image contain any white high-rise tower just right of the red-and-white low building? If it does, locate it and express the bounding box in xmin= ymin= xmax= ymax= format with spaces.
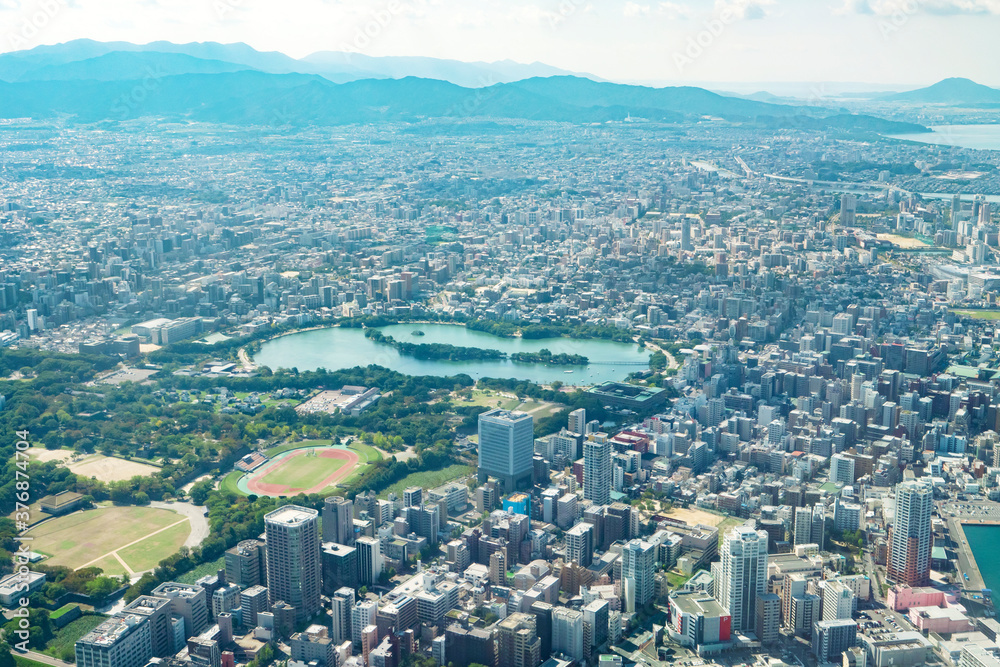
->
xmin=713 ymin=526 xmax=767 ymax=632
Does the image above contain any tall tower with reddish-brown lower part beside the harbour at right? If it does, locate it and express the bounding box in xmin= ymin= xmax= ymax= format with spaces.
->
xmin=886 ymin=480 xmax=934 ymax=586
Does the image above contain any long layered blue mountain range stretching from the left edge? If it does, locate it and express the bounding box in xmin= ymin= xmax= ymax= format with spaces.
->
xmin=0 ymin=40 xmax=952 ymax=133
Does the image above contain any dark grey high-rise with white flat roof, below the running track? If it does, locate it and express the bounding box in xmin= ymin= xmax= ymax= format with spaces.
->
xmin=264 ymin=505 xmax=321 ymax=621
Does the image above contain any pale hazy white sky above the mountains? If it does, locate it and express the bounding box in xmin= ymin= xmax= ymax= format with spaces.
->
xmin=0 ymin=0 xmax=1000 ymax=86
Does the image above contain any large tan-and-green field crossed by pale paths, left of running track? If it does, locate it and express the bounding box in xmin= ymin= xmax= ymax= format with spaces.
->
xmin=28 ymin=507 xmax=191 ymax=576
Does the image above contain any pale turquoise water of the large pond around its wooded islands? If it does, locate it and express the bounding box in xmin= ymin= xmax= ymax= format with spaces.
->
xmin=254 ymin=324 xmax=650 ymax=385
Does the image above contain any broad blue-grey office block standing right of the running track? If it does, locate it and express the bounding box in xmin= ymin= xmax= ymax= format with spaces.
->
xmin=479 ymin=410 xmax=535 ymax=493
